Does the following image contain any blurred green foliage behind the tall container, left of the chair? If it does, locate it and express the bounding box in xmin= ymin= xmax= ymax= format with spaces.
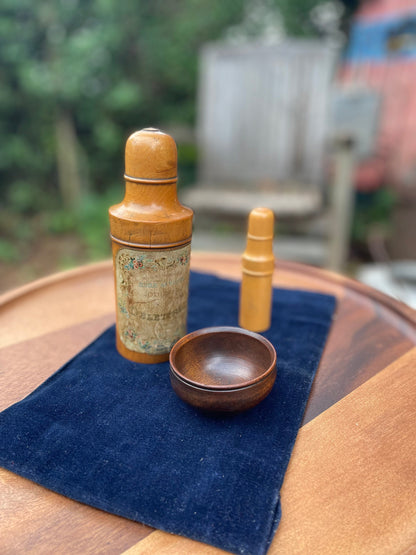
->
xmin=0 ymin=0 xmax=332 ymax=213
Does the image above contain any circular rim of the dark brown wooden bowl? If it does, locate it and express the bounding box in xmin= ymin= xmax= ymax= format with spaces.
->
xmin=169 ymin=326 xmax=277 ymax=391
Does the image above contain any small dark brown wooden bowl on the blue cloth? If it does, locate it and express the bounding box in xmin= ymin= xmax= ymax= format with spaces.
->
xmin=169 ymin=327 xmax=276 ymax=412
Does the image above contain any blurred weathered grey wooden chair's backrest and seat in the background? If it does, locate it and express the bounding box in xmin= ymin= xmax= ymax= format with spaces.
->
xmin=189 ymin=40 xmax=337 ymax=219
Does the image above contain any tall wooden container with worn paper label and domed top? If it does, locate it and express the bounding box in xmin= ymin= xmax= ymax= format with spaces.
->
xmin=109 ymin=128 xmax=193 ymax=363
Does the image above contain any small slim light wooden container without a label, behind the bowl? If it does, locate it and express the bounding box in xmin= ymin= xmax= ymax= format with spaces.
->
xmin=239 ymin=207 xmax=274 ymax=332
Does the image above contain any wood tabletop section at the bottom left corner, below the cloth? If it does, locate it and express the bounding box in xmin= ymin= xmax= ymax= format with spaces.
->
xmin=0 ymin=468 xmax=151 ymax=555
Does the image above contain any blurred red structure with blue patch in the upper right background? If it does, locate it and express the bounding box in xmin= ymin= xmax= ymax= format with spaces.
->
xmin=340 ymin=0 xmax=416 ymax=190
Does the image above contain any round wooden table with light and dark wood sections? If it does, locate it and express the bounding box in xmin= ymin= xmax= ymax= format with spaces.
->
xmin=0 ymin=253 xmax=416 ymax=555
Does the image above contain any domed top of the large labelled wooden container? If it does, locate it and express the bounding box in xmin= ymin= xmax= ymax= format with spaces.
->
xmin=125 ymin=127 xmax=178 ymax=182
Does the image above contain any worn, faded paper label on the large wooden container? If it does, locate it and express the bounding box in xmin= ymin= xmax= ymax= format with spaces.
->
xmin=115 ymin=244 xmax=191 ymax=355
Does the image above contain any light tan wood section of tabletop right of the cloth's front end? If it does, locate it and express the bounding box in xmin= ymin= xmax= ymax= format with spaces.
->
xmin=270 ymin=348 xmax=416 ymax=555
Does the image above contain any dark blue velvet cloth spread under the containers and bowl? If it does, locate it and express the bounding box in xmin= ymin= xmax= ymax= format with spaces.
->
xmin=0 ymin=273 xmax=335 ymax=555
